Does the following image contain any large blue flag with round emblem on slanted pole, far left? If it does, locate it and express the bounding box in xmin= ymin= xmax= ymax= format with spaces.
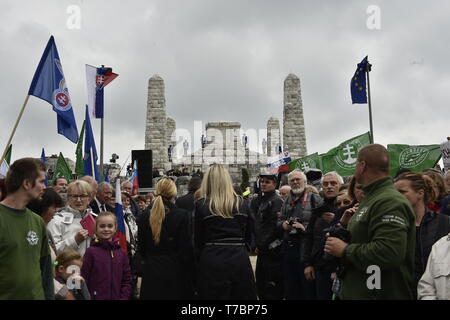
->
xmin=28 ymin=36 xmax=78 ymax=143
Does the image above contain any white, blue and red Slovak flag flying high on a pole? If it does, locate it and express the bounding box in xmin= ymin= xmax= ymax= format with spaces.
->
xmin=86 ymin=64 xmax=119 ymax=119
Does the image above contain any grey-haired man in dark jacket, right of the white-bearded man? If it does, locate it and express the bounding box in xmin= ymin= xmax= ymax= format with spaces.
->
xmin=305 ymin=171 xmax=344 ymax=300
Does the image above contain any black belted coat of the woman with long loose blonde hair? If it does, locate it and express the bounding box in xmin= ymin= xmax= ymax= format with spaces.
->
xmin=194 ymin=198 xmax=257 ymax=300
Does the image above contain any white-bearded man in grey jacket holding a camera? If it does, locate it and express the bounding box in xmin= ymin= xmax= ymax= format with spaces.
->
xmin=278 ymin=170 xmax=323 ymax=300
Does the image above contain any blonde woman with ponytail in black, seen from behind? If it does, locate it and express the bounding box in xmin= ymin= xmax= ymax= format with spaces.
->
xmin=138 ymin=178 xmax=195 ymax=300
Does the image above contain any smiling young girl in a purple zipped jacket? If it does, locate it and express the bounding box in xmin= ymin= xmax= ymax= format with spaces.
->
xmin=81 ymin=212 xmax=131 ymax=300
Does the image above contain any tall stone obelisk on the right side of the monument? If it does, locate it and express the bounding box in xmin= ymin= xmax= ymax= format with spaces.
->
xmin=283 ymin=73 xmax=307 ymax=160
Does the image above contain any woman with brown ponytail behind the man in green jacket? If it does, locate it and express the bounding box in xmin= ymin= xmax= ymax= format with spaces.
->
xmin=395 ymin=172 xmax=450 ymax=286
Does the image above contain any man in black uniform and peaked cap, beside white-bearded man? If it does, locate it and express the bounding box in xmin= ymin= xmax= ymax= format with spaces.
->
xmin=250 ymin=174 xmax=283 ymax=300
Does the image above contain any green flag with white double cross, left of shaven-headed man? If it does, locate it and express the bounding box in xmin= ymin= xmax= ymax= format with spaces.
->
xmin=320 ymin=132 xmax=370 ymax=176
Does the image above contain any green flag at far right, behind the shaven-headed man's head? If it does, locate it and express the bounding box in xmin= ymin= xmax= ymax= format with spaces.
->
xmin=388 ymin=144 xmax=442 ymax=177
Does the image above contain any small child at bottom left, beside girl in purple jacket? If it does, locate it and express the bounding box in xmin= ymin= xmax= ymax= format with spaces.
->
xmin=54 ymin=250 xmax=91 ymax=300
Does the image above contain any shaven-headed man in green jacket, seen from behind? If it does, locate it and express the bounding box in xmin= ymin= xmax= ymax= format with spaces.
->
xmin=325 ymin=144 xmax=416 ymax=300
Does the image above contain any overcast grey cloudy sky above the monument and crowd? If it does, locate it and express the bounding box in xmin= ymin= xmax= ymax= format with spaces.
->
xmin=0 ymin=0 xmax=450 ymax=169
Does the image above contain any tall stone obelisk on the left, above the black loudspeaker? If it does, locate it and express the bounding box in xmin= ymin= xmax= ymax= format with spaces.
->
xmin=145 ymin=75 xmax=168 ymax=171
